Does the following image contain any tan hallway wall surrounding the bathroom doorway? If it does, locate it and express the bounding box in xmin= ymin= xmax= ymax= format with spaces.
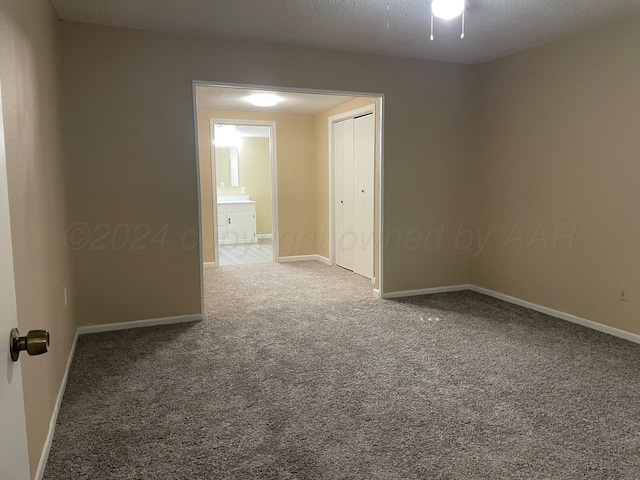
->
xmin=198 ymin=110 xmax=316 ymax=262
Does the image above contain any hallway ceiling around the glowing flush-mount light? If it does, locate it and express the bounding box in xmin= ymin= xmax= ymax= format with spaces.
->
xmin=196 ymin=85 xmax=354 ymax=115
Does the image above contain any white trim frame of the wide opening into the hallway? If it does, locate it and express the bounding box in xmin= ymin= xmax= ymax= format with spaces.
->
xmin=191 ymin=80 xmax=385 ymax=315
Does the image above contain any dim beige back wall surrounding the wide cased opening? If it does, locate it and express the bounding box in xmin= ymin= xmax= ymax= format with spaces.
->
xmin=63 ymin=22 xmax=476 ymax=312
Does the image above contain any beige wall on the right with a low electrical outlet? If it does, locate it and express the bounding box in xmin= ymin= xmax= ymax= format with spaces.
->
xmin=472 ymin=16 xmax=640 ymax=334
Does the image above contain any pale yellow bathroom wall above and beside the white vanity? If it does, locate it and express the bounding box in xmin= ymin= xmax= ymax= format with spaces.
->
xmin=215 ymin=137 xmax=271 ymax=235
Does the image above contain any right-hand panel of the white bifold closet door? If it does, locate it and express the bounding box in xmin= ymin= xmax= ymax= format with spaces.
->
xmin=353 ymin=113 xmax=375 ymax=278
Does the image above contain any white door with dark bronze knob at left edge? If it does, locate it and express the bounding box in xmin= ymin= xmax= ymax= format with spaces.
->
xmin=0 ymin=79 xmax=30 ymax=480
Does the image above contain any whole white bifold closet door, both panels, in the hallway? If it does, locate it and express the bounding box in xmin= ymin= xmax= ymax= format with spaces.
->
xmin=333 ymin=113 xmax=375 ymax=278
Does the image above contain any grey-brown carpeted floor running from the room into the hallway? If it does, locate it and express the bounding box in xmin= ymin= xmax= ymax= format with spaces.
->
xmin=44 ymin=262 xmax=640 ymax=480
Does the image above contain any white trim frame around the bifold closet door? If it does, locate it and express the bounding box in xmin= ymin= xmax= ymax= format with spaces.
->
xmin=327 ymin=102 xmax=384 ymax=295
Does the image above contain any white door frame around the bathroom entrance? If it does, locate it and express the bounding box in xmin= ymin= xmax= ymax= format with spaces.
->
xmin=209 ymin=118 xmax=280 ymax=266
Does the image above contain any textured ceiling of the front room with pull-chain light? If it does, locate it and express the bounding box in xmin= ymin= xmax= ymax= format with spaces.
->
xmin=52 ymin=0 xmax=640 ymax=63
